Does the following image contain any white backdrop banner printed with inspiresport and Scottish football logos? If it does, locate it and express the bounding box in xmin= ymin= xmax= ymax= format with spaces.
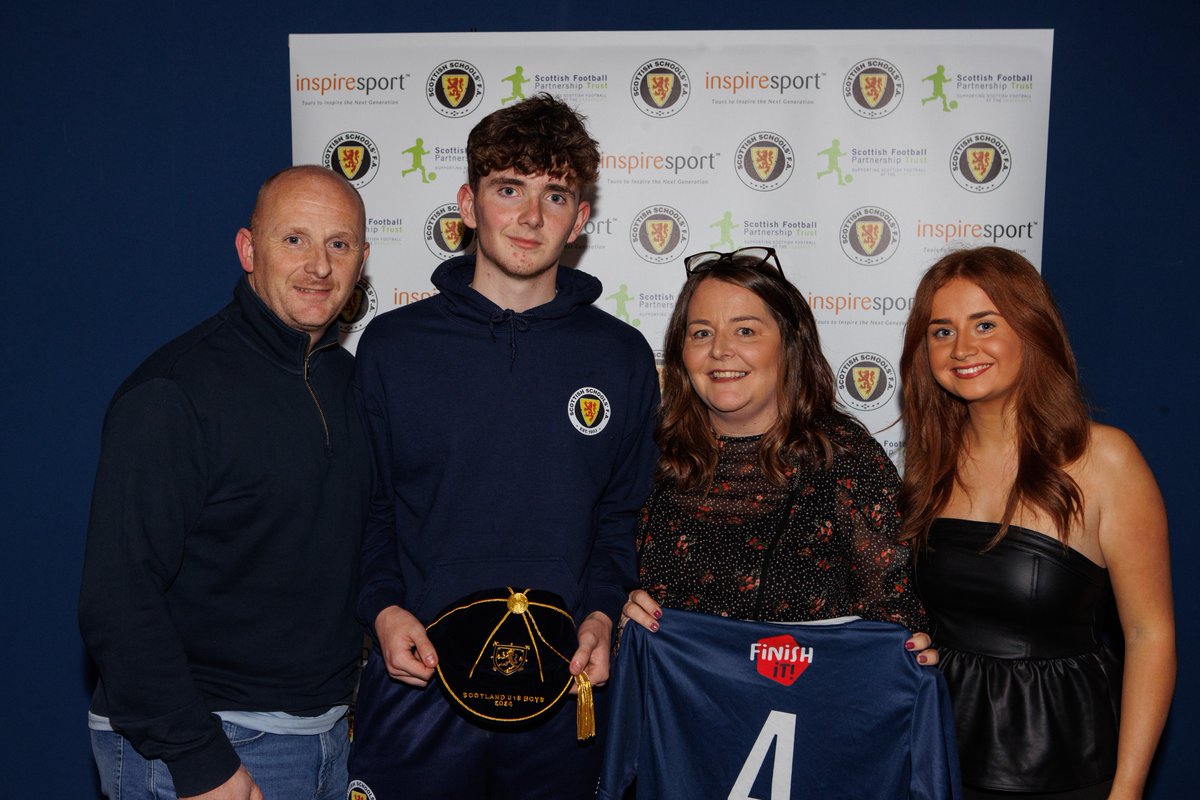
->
xmin=289 ymin=30 xmax=1054 ymax=456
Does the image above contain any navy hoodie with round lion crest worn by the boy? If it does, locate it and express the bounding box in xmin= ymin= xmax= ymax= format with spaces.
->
xmin=354 ymin=255 xmax=659 ymax=626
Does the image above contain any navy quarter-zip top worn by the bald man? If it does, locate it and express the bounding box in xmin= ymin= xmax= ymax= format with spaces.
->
xmin=79 ymin=278 xmax=371 ymax=795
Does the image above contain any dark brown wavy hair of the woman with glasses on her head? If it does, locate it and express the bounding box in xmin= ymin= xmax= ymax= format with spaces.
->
xmin=654 ymin=258 xmax=858 ymax=491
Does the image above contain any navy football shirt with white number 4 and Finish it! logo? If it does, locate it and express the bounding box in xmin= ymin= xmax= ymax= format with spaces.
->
xmin=598 ymin=609 xmax=961 ymax=800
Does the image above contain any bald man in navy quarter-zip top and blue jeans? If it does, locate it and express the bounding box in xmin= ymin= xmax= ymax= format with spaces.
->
xmin=79 ymin=167 xmax=371 ymax=800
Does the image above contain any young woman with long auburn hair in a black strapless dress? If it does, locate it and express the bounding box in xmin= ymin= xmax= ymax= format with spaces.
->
xmin=900 ymin=247 xmax=1175 ymax=800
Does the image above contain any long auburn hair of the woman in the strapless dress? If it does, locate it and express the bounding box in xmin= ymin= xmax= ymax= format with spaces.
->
xmin=900 ymin=247 xmax=1090 ymax=549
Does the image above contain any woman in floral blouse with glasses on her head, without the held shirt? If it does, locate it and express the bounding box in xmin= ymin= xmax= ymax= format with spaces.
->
xmin=624 ymin=247 xmax=937 ymax=638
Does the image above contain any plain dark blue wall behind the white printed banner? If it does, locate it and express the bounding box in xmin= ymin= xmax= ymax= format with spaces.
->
xmin=7 ymin=0 xmax=1200 ymax=800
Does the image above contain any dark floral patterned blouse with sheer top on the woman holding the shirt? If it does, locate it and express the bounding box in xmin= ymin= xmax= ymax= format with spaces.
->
xmin=638 ymin=421 xmax=928 ymax=631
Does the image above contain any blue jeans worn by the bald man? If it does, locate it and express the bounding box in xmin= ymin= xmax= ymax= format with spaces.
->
xmin=91 ymin=718 xmax=350 ymax=800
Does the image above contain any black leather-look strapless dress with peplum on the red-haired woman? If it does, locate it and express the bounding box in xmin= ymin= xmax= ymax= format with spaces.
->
xmin=917 ymin=518 xmax=1121 ymax=792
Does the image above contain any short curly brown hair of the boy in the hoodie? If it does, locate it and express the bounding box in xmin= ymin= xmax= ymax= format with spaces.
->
xmin=467 ymin=92 xmax=600 ymax=190
